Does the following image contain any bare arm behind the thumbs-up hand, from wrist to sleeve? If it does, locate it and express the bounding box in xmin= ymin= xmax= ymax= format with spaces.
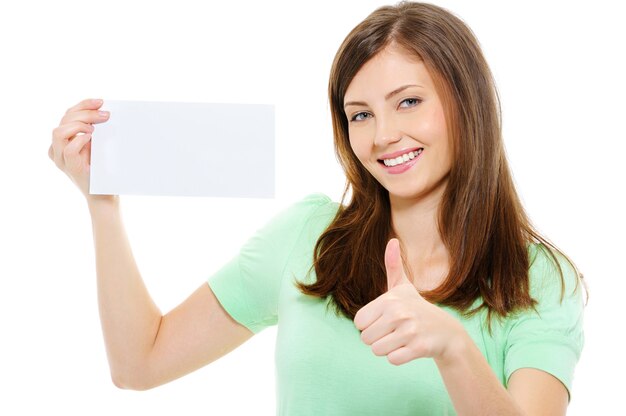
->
xmin=435 ymin=334 xmax=568 ymax=415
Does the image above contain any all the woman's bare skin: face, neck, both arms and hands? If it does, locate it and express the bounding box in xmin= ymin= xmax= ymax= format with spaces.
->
xmin=48 ymin=46 xmax=567 ymax=415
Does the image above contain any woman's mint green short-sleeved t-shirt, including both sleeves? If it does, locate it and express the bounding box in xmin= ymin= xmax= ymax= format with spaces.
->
xmin=208 ymin=194 xmax=583 ymax=416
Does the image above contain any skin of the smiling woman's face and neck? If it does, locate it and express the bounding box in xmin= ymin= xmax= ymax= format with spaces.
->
xmin=344 ymin=43 xmax=452 ymax=290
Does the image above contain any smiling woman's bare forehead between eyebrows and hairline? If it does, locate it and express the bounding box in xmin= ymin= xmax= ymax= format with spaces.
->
xmin=344 ymin=45 xmax=435 ymax=102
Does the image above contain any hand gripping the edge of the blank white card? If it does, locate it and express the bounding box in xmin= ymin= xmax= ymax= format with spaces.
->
xmin=48 ymin=99 xmax=109 ymax=199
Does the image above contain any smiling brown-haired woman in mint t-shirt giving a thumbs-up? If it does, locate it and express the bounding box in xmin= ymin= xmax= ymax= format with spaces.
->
xmin=50 ymin=3 xmax=583 ymax=415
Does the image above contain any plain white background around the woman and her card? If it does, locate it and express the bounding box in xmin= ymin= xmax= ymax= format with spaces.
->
xmin=0 ymin=0 xmax=626 ymax=415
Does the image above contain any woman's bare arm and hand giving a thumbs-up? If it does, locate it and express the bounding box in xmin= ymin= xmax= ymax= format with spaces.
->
xmin=354 ymin=239 xmax=568 ymax=416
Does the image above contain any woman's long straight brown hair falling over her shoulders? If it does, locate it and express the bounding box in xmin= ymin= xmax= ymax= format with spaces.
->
xmin=296 ymin=2 xmax=580 ymax=327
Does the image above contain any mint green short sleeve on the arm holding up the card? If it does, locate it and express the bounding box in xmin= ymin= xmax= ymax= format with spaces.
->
xmin=208 ymin=194 xmax=331 ymax=334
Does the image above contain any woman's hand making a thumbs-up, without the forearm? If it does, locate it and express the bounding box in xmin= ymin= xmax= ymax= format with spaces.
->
xmin=354 ymin=238 xmax=468 ymax=365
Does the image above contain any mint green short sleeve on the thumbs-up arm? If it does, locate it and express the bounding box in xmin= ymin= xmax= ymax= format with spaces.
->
xmin=504 ymin=246 xmax=584 ymax=399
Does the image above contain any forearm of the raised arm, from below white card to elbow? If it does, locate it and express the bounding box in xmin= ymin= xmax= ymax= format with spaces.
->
xmin=88 ymin=197 xmax=162 ymax=387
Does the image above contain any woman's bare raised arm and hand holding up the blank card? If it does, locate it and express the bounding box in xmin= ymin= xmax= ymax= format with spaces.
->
xmin=49 ymin=100 xmax=253 ymax=390
